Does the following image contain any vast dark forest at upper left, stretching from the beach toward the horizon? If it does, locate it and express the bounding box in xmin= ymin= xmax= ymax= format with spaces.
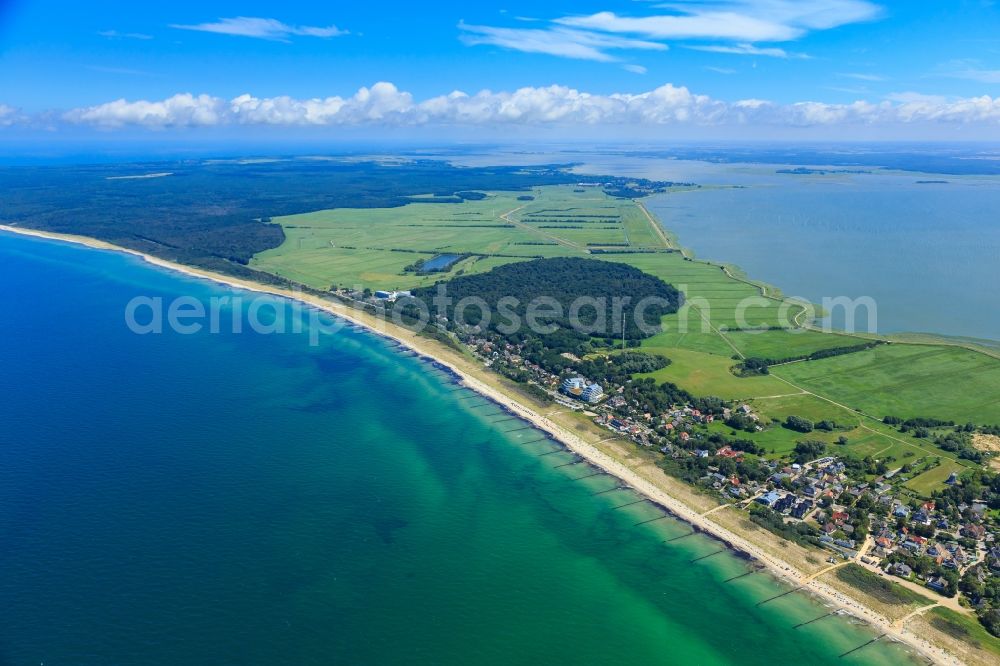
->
xmin=0 ymin=159 xmax=648 ymax=280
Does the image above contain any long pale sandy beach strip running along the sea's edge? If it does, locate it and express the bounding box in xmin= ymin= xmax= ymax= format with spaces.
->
xmin=0 ymin=224 xmax=962 ymax=664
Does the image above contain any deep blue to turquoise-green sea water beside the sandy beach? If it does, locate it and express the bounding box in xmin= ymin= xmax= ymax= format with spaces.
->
xmin=0 ymin=235 xmax=910 ymax=666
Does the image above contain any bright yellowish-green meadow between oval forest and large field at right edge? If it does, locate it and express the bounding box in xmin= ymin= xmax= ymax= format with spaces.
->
xmin=641 ymin=345 xmax=788 ymax=400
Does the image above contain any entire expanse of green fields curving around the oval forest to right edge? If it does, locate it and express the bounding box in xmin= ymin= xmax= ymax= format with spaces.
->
xmin=252 ymin=185 xmax=1000 ymax=466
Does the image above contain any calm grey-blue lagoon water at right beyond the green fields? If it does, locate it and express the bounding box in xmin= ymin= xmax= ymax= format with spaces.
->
xmin=586 ymin=159 xmax=1000 ymax=345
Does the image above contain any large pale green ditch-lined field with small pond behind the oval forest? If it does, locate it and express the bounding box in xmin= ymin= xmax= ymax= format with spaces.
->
xmin=251 ymin=186 xmax=666 ymax=289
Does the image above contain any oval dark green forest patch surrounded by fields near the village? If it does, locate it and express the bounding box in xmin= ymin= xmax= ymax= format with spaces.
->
xmin=404 ymin=257 xmax=682 ymax=344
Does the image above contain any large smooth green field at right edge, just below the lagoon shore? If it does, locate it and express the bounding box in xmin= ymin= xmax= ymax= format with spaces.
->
xmin=772 ymin=344 xmax=1000 ymax=423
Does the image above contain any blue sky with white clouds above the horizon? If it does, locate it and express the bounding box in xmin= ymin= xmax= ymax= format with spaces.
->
xmin=0 ymin=0 xmax=1000 ymax=138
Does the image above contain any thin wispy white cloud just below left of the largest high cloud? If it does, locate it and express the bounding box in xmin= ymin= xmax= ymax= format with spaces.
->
xmin=458 ymin=23 xmax=668 ymax=62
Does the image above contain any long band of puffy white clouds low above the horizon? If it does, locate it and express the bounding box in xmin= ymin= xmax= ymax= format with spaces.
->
xmin=52 ymin=82 xmax=1000 ymax=129
